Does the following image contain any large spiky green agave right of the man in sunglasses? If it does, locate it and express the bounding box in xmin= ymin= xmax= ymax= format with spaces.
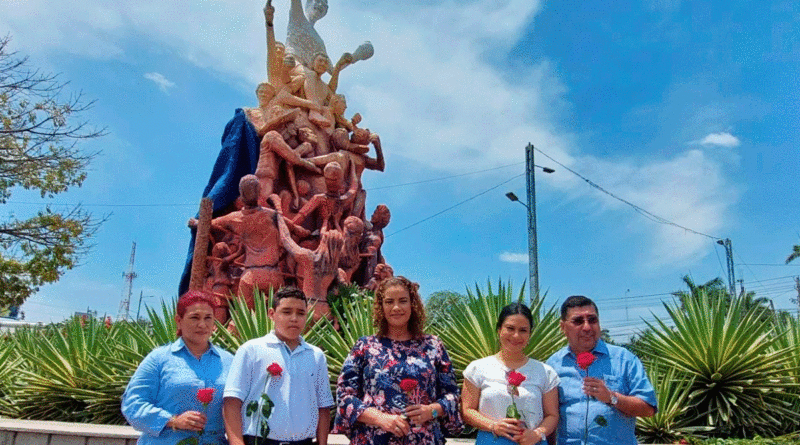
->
xmin=640 ymin=291 xmax=799 ymax=435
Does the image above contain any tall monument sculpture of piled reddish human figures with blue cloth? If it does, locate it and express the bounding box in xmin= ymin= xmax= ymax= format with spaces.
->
xmin=179 ymin=0 xmax=392 ymax=322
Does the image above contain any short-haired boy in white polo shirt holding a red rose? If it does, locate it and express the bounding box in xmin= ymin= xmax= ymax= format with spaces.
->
xmin=223 ymin=287 xmax=334 ymax=445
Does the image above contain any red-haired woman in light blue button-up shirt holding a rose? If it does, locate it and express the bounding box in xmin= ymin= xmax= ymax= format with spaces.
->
xmin=122 ymin=291 xmax=233 ymax=445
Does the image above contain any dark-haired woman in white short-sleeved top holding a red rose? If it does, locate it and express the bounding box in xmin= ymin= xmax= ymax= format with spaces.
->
xmin=461 ymin=303 xmax=559 ymax=445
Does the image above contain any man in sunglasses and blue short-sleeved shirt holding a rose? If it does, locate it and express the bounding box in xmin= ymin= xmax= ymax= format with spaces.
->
xmin=547 ymin=296 xmax=657 ymax=445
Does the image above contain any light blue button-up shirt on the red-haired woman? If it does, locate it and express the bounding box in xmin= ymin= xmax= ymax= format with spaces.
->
xmin=122 ymin=338 xmax=233 ymax=445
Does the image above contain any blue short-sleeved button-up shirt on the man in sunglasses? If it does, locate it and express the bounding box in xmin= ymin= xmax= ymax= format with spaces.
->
xmin=547 ymin=340 xmax=658 ymax=445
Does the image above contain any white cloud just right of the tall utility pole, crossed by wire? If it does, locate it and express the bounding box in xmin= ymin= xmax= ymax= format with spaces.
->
xmin=548 ymin=149 xmax=739 ymax=270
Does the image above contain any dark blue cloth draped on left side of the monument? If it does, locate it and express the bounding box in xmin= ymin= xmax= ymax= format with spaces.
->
xmin=178 ymin=108 xmax=260 ymax=295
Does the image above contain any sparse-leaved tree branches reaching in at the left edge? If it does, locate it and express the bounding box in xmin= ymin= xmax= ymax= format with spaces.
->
xmin=0 ymin=36 xmax=104 ymax=306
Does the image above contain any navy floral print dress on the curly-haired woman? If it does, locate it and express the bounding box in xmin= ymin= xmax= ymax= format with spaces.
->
xmin=335 ymin=335 xmax=463 ymax=445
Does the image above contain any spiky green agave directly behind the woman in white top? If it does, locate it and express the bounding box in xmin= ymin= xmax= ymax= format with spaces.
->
xmin=434 ymin=281 xmax=566 ymax=378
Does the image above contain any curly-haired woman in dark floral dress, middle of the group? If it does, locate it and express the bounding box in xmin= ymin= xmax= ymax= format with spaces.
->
xmin=335 ymin=277 xmax=462 ymax=445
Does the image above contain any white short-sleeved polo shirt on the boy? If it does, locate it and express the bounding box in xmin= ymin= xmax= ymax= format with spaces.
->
xmin=224 ymin=331 xmax=334 ymax=441
